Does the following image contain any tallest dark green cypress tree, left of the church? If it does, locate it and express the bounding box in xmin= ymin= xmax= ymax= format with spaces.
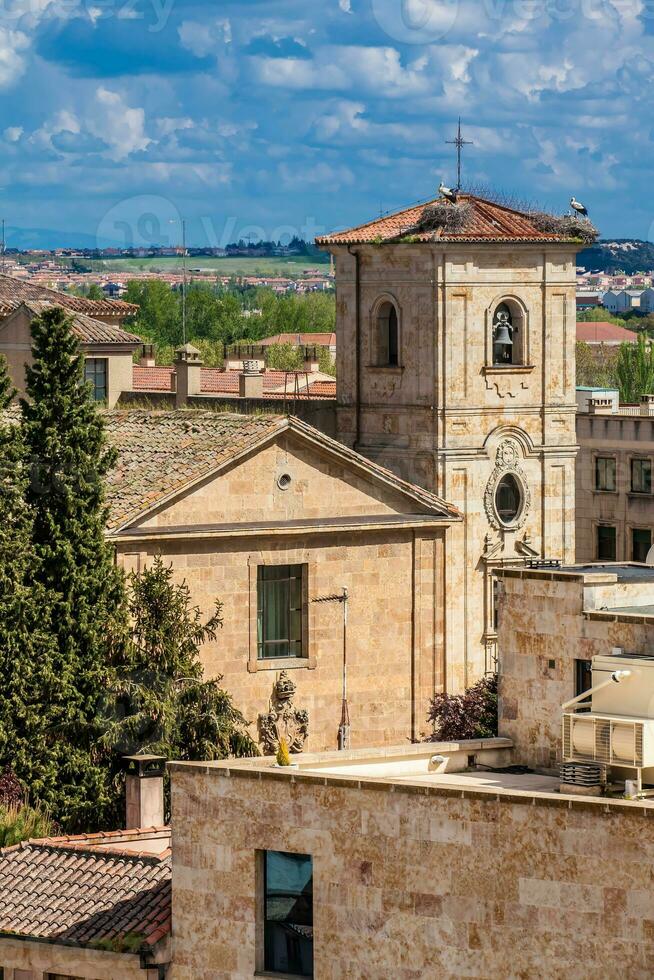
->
xmin=21 ymin=307 xmax=125 ymax=830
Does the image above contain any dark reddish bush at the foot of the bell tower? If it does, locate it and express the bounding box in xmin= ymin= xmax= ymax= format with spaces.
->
xmin=427 ymin=674 xmax=497 ymax=742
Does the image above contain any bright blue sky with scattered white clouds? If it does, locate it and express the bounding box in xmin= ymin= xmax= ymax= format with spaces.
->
xmin=0 ymin=0 xmax=654 ymax=244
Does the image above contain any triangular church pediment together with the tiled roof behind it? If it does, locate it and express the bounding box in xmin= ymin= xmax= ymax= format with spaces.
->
xmin=104 ymin=413 xmax=458 ymax=530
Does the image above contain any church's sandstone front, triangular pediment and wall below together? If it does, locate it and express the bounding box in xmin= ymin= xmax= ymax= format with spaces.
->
xmin=111 ymin=426 xmax=457 ymax=751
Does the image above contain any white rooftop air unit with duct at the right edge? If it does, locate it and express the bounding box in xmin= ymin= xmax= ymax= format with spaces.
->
xmin=561 ymin=652 xmax=654 ymax=793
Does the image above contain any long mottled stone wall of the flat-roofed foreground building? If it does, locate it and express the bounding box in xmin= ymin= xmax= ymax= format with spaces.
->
xmin=170 ymin=745 xmax=654 ymax=980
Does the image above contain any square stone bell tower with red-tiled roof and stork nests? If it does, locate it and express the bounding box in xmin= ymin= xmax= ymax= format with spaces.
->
xmin=318 ymin=194 xmax=579 ymax=691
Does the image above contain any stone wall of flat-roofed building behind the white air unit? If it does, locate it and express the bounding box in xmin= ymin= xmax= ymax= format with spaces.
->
xmin=497 ymin=565 xmax=654 ymax=768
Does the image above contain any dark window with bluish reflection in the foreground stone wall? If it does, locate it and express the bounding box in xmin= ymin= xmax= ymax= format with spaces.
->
xmin=263 ymin=851 xmax=313 ymax=977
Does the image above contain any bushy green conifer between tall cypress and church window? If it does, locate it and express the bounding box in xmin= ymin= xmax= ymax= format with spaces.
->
xmin=104 ymin=557 xmax=258 ymax=777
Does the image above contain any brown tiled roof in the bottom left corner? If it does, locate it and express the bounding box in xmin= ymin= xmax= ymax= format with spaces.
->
xmin=0 ymin=831 xmax=171 ymax=952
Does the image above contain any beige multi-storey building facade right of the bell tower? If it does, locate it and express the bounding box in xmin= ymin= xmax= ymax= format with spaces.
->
xmin=576 ymin=404 xmax=654 ymax=561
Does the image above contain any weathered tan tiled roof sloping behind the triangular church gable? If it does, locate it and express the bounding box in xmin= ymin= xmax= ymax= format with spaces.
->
xmin=104 ymin=410 xmax=459 ymax=531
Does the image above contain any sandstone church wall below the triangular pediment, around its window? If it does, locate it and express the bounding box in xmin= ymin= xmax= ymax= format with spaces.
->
xmin=118 ymin=528 xmax=445 ymax=751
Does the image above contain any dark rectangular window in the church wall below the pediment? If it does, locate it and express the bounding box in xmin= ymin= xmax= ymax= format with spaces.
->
xmin=257 ymin=565 xmax=306 ymax=660
